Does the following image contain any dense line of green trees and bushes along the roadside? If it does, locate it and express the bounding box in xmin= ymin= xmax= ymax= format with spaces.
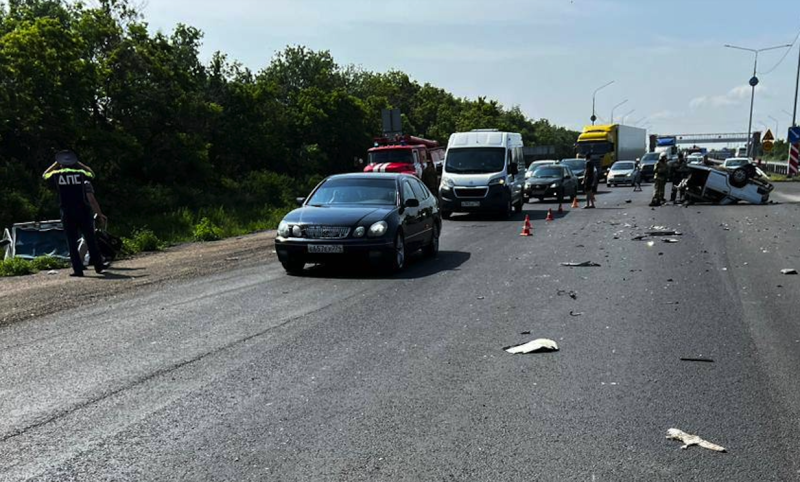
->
xmin=0 ymin=0 xmax=578 ymax=241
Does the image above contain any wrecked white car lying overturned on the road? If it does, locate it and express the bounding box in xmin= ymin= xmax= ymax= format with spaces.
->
xmin=680 ymin=164 xmax=774 ymax=204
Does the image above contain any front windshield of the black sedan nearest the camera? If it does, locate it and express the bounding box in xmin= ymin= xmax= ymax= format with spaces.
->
xmin=308 ymin=178 xmax=397 ymax=207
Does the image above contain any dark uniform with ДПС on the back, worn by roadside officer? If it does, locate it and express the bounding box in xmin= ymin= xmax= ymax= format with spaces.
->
xmin=44 ymin=154 xmax=104 ymax=275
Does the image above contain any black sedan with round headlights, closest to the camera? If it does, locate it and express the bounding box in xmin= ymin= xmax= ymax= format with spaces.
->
xmin=275 ymin=173 xmax=442 ymax=274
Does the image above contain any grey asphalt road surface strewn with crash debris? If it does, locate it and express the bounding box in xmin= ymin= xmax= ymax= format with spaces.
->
xmin=0 ymin=185 xmax=800 ymax=481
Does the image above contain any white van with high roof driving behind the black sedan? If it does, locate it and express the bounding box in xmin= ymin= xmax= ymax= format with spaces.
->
xmin=439 ymin=129 xmax=525 ymax=219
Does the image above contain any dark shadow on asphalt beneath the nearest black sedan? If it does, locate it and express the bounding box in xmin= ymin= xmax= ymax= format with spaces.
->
xmin=302 ymin=251 xmax=472 ymax=279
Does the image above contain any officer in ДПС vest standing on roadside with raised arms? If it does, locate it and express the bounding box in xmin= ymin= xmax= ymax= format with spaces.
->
xmin=42 ymin=151 xmax=108 ymax=277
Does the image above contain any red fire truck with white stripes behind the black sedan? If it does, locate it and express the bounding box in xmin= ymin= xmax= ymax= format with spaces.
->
xmin=364 ymin=136 xmax=445 ymax=177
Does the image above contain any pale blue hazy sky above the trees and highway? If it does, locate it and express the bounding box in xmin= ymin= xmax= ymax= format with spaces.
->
xmin=144 ymin=0 xmax=800 ymax=142
